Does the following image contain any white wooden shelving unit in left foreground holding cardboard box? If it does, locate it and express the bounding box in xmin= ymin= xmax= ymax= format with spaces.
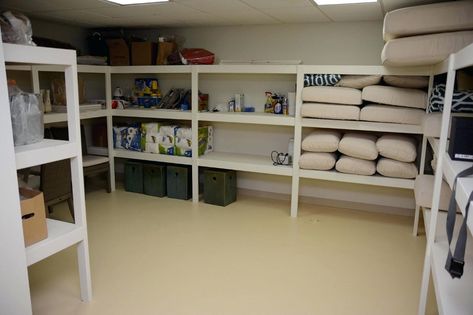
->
xmin=0 ymin=43 xmax=92 ymax=315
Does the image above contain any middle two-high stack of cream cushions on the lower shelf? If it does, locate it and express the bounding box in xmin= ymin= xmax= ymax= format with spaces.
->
xmin=335 ymin=132 xmax=378 ymax=175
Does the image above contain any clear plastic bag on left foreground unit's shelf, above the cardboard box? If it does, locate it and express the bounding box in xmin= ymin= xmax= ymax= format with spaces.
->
xmin=10 ymin=91 xmax=44 ymax=146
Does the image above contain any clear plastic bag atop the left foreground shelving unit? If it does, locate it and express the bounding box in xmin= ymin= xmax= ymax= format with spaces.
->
xmin=0 ymin=11 xmax=36 ymax=46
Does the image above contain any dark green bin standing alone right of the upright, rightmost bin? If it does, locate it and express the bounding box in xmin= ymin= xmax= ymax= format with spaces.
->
xmin=204 ymin=170 xmax=236 ymax=207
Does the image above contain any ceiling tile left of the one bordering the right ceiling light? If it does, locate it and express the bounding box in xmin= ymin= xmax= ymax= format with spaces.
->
xmin=260 ymin=6 xmax=330 ymax=23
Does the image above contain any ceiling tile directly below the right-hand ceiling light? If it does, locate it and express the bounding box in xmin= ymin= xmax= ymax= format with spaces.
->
xmin=318 ymin=2 xmax=383 ymax=22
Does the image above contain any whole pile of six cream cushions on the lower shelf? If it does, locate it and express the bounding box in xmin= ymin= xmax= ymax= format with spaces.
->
xmin=299 ymin=129 xmax=418 ymax=179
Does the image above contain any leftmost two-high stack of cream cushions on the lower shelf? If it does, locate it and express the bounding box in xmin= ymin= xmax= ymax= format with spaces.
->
xmin=299 ymin=129 xmax=341 ymax=171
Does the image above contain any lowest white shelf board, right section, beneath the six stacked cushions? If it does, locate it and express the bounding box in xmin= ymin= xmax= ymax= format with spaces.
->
xmin=299 ymin=169 xmax=414 ymax=189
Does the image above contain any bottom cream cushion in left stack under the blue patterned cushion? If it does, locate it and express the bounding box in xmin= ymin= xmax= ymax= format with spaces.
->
xmin=301 ymin=103 xmax=360 ymax=120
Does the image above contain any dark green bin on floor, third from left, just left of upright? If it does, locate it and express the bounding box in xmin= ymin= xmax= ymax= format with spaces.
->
xmin=166 ymin=165 xmax=192 ymax=200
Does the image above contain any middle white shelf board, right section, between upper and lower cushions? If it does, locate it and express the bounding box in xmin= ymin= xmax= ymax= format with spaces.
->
xmin=301 ymin=118 xmax=422 ymax=134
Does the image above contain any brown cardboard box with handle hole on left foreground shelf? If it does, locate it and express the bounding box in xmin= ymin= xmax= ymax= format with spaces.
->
xmin=20 ymin=188 xmax=48 ymax=246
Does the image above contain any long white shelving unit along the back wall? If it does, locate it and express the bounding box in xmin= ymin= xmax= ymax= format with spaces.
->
xmin=79 ymin=65 xmax=432 ymax=217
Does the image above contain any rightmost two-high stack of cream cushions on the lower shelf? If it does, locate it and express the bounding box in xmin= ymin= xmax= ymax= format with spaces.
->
xmin=376 ymin=134 xmax=418 ymax=178
